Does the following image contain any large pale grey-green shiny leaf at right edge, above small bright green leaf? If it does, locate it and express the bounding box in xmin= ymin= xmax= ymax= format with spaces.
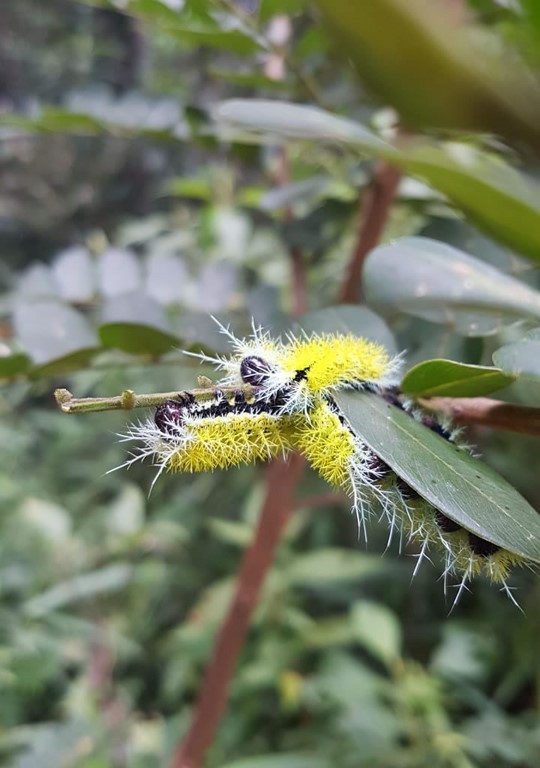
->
xmin=364 ymin=237 xmax=540 ymax=336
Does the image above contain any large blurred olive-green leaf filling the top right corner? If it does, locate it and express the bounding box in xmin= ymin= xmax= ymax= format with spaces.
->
xmin=312 ymin=0 xmax=540 ymax=152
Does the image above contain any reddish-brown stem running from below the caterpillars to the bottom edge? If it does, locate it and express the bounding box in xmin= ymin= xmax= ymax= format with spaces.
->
xmin=171 ymin=455 xmax=303 ymax=768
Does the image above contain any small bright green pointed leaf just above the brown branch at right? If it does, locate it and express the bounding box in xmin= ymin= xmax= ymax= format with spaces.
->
xmin=400 ymin=360 xmax=515 ymax=397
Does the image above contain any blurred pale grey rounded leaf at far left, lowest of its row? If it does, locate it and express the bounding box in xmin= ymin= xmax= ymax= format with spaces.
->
xmin=13 ymin=301 xmax=99 ymax=364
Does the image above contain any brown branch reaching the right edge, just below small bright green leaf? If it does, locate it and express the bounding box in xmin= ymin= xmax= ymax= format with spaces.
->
xmin=419 ymin=397 xmax=540 ymax=435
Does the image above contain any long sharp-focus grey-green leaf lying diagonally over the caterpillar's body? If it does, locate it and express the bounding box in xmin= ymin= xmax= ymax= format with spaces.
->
xmin=335 ymin=392 xmax=540 ymax=561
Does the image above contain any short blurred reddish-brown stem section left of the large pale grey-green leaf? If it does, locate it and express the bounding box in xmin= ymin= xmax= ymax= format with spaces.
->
xmin=340 ymin=160 xmax=402 ymax=303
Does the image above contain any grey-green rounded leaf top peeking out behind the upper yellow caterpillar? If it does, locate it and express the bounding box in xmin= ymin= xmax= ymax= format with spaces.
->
xmin=299 ymin=304 xmax=397 ymax=355
